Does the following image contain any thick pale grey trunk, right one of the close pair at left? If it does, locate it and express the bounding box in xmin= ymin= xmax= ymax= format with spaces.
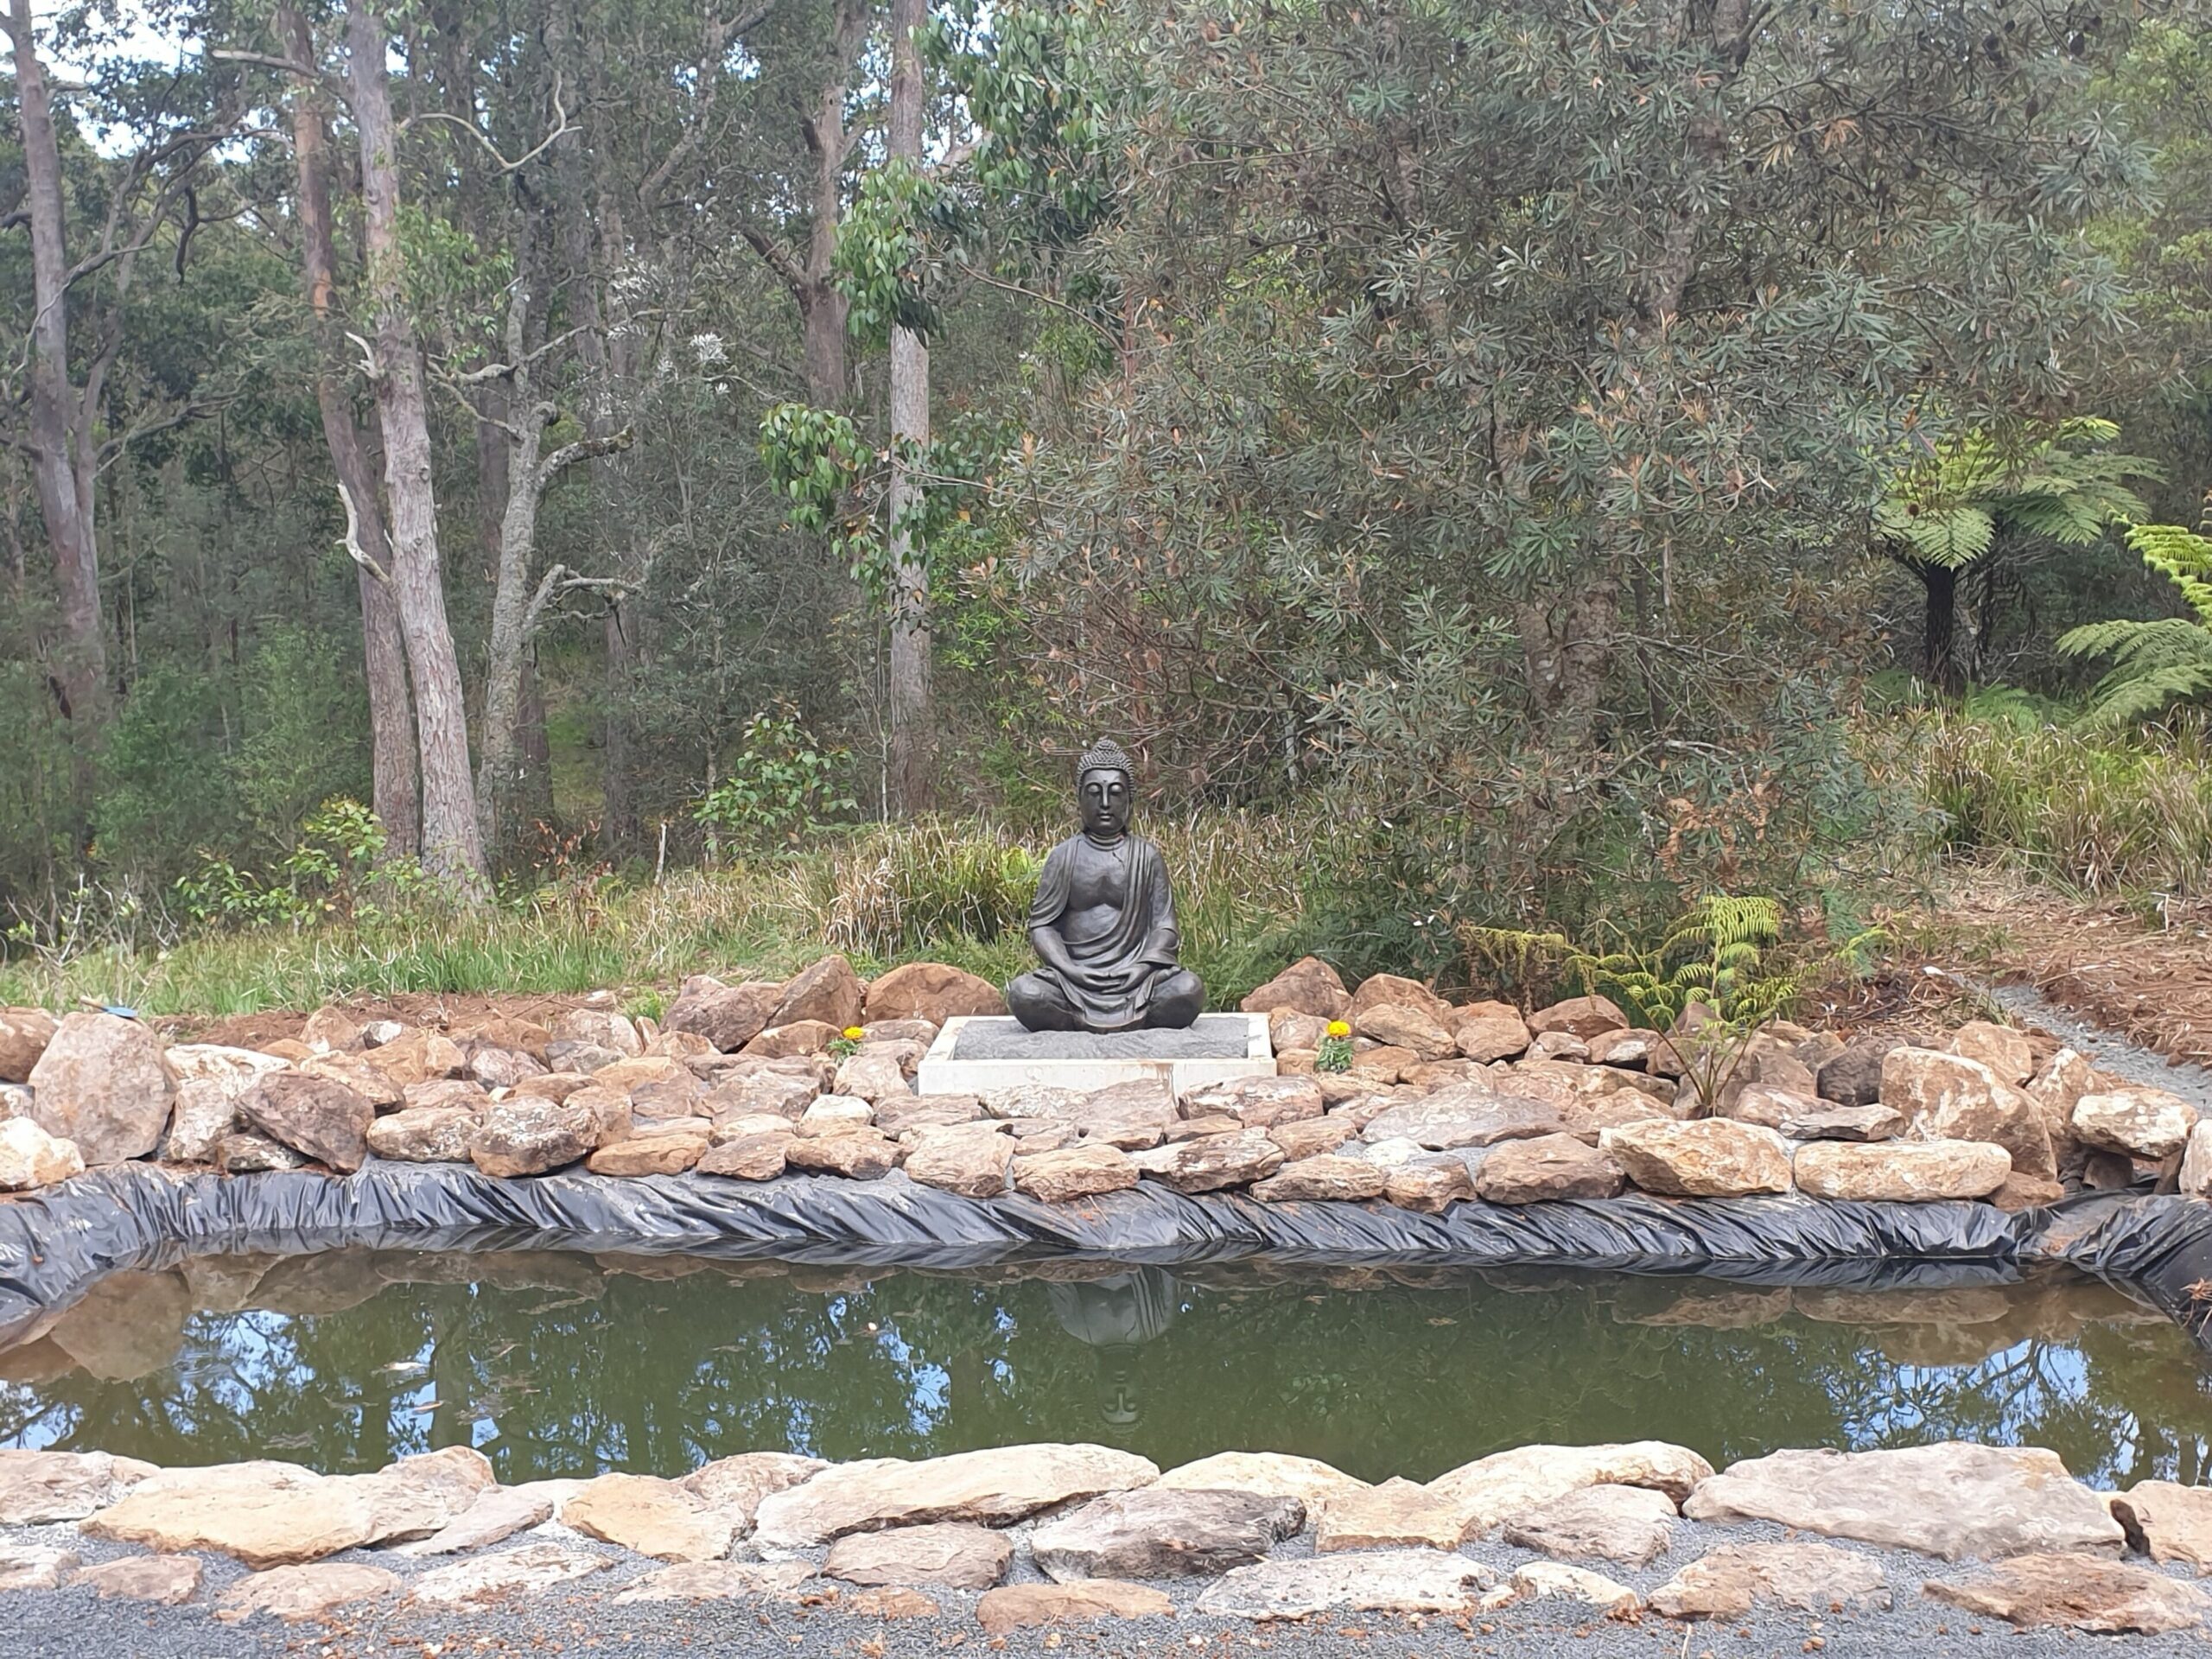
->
xmin=345 ymin=0 xmax=486 ymax=893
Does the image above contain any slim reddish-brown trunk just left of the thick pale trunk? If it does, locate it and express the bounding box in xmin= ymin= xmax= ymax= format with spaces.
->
xmin=276 ymin=7 xmax=423 ymax=858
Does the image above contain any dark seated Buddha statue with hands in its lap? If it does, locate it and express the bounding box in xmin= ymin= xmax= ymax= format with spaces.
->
xmin=1007 ymin=739 xmax=1205 ymax=1031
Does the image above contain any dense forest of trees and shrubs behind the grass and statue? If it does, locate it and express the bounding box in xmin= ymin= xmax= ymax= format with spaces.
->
xmin=0 ymin=0 xmax=2212 ymax=995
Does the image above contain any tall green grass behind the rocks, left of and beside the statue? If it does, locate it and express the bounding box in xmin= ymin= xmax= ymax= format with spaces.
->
xmin=0 ymin=814 xmax=1330 ymax=1015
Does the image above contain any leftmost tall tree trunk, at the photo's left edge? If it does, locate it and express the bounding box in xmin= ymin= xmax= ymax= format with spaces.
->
xmin=7 ymin=0 xmax=108 ymax=732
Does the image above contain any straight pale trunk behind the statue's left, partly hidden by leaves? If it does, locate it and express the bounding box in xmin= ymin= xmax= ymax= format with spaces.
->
xmin=887 ymin=0 xmax=936 ymax=814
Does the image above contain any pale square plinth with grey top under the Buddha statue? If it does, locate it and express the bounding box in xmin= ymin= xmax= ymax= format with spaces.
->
xmin=913 ymin=1013 xmax=1274 ymax=1095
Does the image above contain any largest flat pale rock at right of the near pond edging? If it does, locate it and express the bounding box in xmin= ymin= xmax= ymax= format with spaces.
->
xmin=1683 ymin=1440 xmax=2124 ymax=1561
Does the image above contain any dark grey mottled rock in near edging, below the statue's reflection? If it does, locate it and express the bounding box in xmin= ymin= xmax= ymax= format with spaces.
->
xmin=1028 ymin=1486 xmax=1305 ymax=1584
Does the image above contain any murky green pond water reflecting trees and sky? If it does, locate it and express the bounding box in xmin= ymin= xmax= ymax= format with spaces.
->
xmin=0 ymin=1249 xmax=2212 ymax=1484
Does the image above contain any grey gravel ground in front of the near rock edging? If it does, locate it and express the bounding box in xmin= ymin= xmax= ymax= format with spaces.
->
xmin=0 ymin=1522 xmax=2212 ymax=1659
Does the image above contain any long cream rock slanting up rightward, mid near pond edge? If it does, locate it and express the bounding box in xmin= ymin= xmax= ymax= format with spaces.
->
xmin=754 ymin=1445 xmax=1159 ymax=1548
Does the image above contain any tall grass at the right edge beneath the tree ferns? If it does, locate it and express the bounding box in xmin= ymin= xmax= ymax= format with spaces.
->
xmin=1918 ymin=712 xmax=2212 ymax=893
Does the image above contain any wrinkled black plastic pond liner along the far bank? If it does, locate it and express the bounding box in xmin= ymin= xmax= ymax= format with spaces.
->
xmin=0 ymin=1161 xmax=2212 ymax=1347
